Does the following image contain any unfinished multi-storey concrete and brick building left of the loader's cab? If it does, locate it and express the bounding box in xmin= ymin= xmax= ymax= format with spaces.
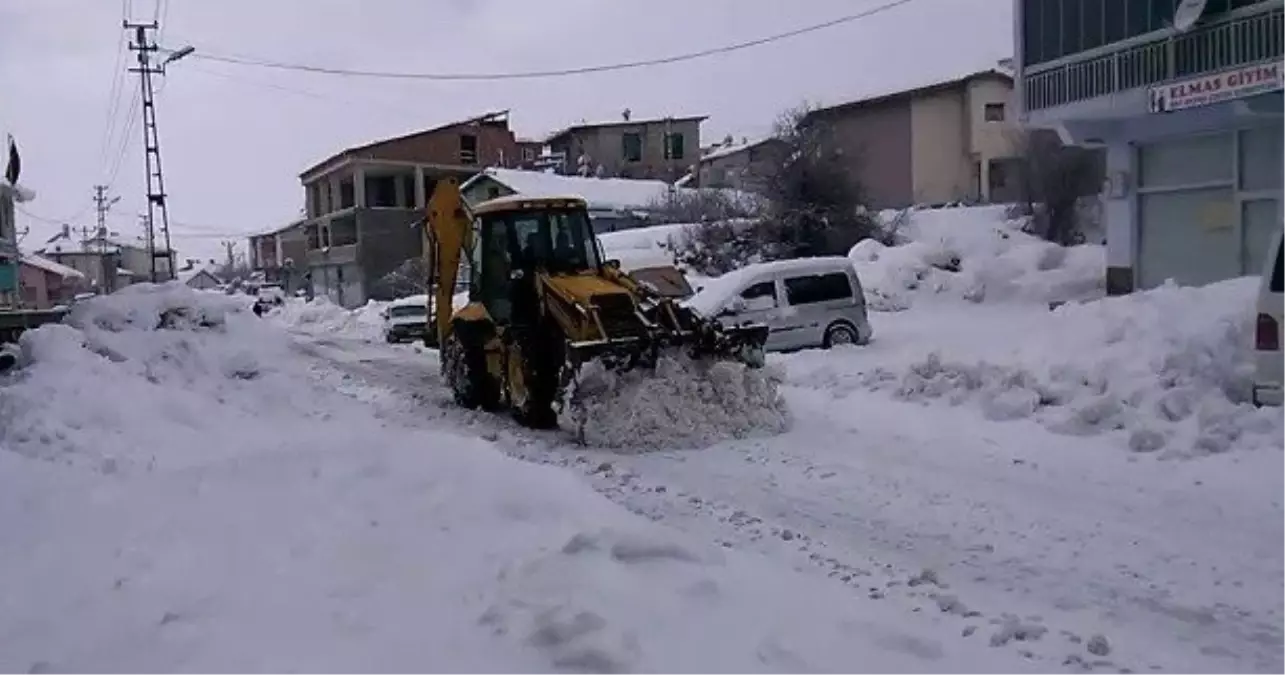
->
xmin=299 ymin=111 xmax=522 ymax=307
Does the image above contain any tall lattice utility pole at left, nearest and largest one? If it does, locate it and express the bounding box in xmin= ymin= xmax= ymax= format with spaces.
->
xmin=123 ymin=21 xmax=173 ymax=283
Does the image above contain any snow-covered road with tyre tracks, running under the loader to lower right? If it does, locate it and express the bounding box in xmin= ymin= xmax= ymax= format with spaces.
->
xmin=299 ymin=328 xmax=1285 ymax=674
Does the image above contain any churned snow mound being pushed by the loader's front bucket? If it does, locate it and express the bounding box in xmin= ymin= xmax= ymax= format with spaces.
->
xmin=565 ymin=356 xmax=790 ymax=451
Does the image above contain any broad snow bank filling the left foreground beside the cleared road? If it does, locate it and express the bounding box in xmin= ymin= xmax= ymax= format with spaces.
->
xmin=0 ymin=285 xmax=1027 ymax=675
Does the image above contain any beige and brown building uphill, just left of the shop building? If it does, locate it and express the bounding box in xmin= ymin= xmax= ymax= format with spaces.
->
xmin=801 ymin=68 xmax=1019 ymax=208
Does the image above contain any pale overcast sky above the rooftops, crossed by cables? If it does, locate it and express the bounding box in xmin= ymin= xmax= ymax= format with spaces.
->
xmin=0 ymin=0 xmax=1013 ymax=257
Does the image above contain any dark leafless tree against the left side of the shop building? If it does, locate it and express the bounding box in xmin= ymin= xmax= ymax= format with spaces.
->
xmin=1018 ymin=130 xmax=1105 ymax=246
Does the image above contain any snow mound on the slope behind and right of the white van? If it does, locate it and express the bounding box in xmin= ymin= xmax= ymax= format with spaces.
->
xmin=848 ymin=206 xmax=1106 ymax=311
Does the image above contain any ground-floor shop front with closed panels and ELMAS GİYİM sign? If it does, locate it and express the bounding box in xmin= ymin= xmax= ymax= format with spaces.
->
xmin=1064 ymin=64 xmax=1285 ymax=293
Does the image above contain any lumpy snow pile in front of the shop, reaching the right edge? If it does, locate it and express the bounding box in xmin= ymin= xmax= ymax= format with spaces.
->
xmin=848 ymin=278 xmax=1285 ymax=455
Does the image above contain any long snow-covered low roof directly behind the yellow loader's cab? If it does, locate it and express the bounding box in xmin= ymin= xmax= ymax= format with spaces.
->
xmin=461 ymin=168 xmax=671 ymax=210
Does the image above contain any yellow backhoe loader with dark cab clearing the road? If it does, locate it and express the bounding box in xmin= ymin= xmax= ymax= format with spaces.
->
xmin=424 ymin=179 xmax=767 ymax=428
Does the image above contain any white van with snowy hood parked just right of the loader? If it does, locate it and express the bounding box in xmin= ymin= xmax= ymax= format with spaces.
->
xmin=686 ymin=256 xmax=874 ymax=351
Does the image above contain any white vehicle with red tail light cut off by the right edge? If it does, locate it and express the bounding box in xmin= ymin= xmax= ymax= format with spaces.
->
xmin=1253 ymin=229 xmax=1285 ymax=405
